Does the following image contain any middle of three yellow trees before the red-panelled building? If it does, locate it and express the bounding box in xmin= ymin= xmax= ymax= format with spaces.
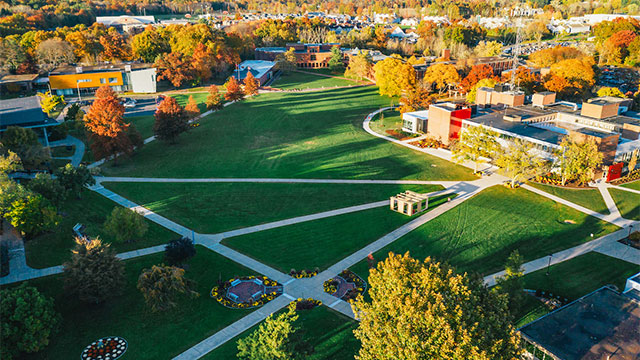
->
xmin=496 ymin=139 xmax=546 ymax=188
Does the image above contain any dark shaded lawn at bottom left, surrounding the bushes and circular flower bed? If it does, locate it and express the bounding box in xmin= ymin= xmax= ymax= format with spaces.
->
xmin=15 ymin=246 xmax=262 ymax=360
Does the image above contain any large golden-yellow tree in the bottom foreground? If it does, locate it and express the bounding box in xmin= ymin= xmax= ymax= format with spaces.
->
xmin=351 ymin=253 xmax=520 ymax=360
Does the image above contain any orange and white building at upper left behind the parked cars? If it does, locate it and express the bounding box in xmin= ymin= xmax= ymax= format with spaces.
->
xmin=49 ymin=64 xmax=156 ymax=95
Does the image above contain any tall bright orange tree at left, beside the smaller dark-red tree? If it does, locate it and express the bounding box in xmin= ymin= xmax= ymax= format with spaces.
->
xmin=83 ymin=85 xmax=134 ymax=159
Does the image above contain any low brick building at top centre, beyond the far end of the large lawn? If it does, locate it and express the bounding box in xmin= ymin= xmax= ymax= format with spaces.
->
xmin=255 ymin=43 xmax=340 ymax=69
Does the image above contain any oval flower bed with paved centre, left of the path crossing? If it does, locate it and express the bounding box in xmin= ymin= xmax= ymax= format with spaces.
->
xmin=211 ymin=276 xmax=283 ymax=309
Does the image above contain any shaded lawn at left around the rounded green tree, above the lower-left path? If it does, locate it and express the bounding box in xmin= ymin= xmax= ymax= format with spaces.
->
xmin=25 ymin=190 xmax=178 ymax=268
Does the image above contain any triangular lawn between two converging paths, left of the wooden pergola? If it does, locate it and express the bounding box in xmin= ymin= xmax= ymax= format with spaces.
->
xmin=103 ymin=183 xmax=442 ymax=233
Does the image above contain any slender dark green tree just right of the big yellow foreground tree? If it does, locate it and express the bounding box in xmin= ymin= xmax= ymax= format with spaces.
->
xmin=495 ymin=250 xmax=527 ymax=316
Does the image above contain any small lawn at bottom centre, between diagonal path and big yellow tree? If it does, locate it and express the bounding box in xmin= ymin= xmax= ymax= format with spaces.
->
xmin=202 ymin=306 xmax=360 ymax=360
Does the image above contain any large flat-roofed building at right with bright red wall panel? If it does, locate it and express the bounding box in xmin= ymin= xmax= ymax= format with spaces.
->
xmin=403 ymin=86 xmax=640 ymax=175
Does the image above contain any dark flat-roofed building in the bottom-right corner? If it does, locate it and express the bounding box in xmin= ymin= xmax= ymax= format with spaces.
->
xmin=519 ymin=284 xmax=640 ymax=360
